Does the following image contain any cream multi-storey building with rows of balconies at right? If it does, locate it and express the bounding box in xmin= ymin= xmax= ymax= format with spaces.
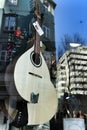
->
xmin=56 ymin=46 xmax=87 ymax=113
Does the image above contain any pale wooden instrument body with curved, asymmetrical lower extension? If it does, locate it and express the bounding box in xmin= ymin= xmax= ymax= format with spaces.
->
xmin=14 ymin=46 xmax=57 ymax=125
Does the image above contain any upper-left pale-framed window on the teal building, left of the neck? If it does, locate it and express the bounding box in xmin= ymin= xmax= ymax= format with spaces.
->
xmin=3 ymin=14 xmax=17 ymax=32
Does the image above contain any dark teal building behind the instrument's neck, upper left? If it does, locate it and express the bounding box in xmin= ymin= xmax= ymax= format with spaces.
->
xmin=0 ymin=0 xmax=56 ymax=67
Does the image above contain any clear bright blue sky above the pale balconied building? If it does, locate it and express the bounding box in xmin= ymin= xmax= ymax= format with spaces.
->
xmin=54 ymin=0 xmax=87 ymax=61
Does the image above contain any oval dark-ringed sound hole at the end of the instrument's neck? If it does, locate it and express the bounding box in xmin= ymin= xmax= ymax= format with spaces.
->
xmin=30 ymin=52 xmax=42 ymax=67
